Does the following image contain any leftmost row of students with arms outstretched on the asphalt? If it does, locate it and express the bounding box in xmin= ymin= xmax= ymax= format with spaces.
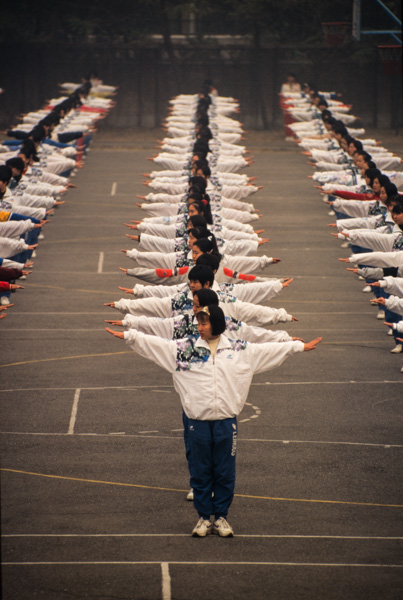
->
xmin=0 ymin=76 xmax=117 ymax=318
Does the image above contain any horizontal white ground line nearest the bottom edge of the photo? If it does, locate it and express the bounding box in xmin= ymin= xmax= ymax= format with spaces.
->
xmin=2 ymin=560 xmax=403 ymax=569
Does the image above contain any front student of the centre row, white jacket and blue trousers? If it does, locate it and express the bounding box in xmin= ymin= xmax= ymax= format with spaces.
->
xmin=106 ymin=305 xmax=322 ymax=537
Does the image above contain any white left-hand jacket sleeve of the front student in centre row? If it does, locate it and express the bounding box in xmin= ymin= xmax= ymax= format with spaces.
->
xmin=124 ymin=329 xmax=177 ymax=373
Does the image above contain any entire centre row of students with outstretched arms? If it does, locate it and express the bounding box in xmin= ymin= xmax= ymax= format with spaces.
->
xmin=106 ymin=85 xmax=320 ymax=537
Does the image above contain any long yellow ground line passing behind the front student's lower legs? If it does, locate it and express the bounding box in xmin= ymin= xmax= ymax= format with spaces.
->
xmin=0 ymin=468 xmax=403 ymax=508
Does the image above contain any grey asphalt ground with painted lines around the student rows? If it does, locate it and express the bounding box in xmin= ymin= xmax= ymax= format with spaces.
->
xmin=0 ymin=125 xmax=403 ymax=600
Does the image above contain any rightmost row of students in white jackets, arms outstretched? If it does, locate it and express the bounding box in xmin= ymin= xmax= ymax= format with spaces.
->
xmin=280 ymin=83 xmax=403 ymax=372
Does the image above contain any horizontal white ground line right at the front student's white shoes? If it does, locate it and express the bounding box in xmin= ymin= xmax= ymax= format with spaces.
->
xmin=0 ymin=533 xmax=403 ymax=541
